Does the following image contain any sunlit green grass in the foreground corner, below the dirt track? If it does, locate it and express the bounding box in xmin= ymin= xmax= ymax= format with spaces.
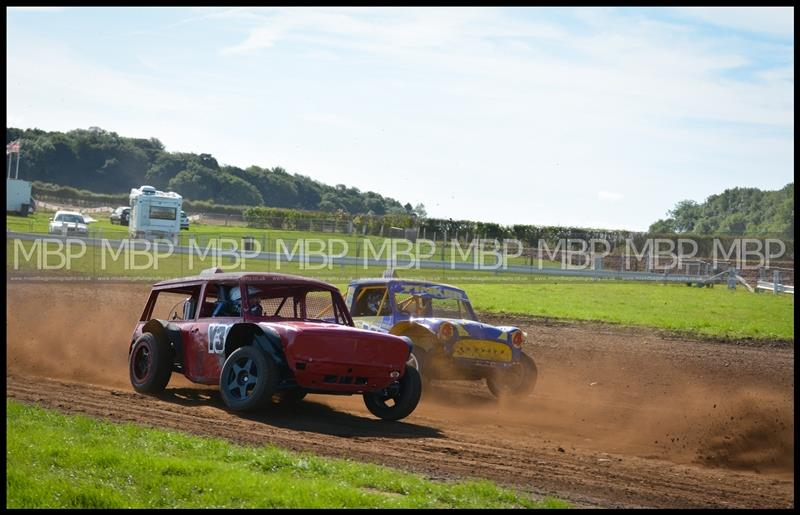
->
xmin=6 ymin=399 xmax=569 ymax=508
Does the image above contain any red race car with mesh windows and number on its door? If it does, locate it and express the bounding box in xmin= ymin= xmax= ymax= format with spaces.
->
xmin=128 ymin=269 xmax=422 ymax=420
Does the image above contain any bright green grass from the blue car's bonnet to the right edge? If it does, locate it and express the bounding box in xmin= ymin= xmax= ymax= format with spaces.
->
xmin=468 ymin=281 xmax=794 ymax=340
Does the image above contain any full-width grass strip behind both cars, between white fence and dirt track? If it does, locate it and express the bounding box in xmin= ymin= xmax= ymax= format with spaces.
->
xmin=6 ymin=222 xmax=794 ymax=340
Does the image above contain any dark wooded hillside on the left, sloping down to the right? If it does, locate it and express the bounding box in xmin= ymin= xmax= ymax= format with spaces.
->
xmin=6 ymin=127 xmax=424 ymax=219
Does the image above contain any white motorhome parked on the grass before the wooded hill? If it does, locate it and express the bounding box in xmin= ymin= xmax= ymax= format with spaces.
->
xmin=128 ymin=186 xmax=183 ymax=241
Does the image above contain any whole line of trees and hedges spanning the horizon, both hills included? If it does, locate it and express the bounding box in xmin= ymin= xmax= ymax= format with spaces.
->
xmin=6 ymin=128 xmax=794 ymax=245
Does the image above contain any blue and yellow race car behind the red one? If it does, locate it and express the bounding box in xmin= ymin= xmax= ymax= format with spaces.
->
xmin=345 ymin=278 xmax=537 ymax=397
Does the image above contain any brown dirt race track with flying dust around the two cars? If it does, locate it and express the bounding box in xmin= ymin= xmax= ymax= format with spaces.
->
xmin=6 ymin=282 xmax=794 ymax=507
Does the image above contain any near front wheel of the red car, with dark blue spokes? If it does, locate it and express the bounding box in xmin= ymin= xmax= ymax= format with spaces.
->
xmin=219 ymin=345 xmax=280 ymax=411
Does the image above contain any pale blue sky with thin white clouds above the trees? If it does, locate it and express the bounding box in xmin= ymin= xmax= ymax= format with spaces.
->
xmin=6 ymin=7 xmax=794 ymax=230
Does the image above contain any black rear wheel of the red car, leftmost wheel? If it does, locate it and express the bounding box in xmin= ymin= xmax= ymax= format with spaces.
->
xmin=128 ymin=333 xmax=172 ymax=394
